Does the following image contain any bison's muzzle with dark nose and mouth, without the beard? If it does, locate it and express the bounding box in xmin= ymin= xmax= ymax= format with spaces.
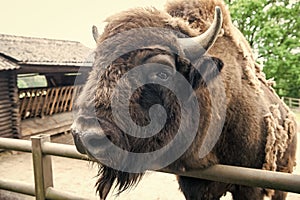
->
xmin=71 ymin=116 xmax=128 ymax=166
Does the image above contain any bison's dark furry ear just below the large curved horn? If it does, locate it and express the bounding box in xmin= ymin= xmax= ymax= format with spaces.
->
xmin=179 ymin=56 xmax=224 ymax=89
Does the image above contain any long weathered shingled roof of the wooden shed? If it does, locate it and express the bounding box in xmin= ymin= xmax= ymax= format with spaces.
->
xmin=0 ymin=34 xmax=92 ymax=66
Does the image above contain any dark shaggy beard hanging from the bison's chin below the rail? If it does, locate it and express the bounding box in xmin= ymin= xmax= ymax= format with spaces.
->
xmin=96 ymin=164 xmax=144 ymax=200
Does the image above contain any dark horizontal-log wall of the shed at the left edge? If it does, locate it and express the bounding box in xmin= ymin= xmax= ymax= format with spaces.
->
xmin=0 ymin=70 xmax=20 ymax=138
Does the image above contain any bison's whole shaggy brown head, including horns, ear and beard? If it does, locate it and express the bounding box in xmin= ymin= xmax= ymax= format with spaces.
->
xmin=72 ymin=8 xmax=223 ymax=199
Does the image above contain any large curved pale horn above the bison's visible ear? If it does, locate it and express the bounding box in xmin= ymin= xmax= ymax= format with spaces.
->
xmin=178 ymin=6 xmax=223 ymax=59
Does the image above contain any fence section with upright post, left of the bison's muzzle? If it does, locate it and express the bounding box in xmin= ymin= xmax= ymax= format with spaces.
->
xmin=0 ymin=135 xmax=89 ymax=200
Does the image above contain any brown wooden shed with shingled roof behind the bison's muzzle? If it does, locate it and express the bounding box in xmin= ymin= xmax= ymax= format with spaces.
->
xmin=0 ymin=34 xmax=93 ymax=138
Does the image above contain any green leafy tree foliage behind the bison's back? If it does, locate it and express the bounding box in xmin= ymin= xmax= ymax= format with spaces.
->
xmin=225 ymin=0 xmax=300 ymax=98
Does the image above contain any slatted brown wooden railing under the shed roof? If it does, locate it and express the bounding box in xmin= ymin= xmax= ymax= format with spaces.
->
xmin=19 ymin=85 xmax=82 ymax=120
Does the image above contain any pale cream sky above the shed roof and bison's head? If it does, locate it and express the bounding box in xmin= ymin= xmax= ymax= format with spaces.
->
xmin=0 ymin=0 xmax=166 ymax=48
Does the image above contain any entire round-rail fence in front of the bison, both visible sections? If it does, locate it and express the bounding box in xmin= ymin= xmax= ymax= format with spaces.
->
xmin=0 ymin=135 xmax=300 ymax=200
